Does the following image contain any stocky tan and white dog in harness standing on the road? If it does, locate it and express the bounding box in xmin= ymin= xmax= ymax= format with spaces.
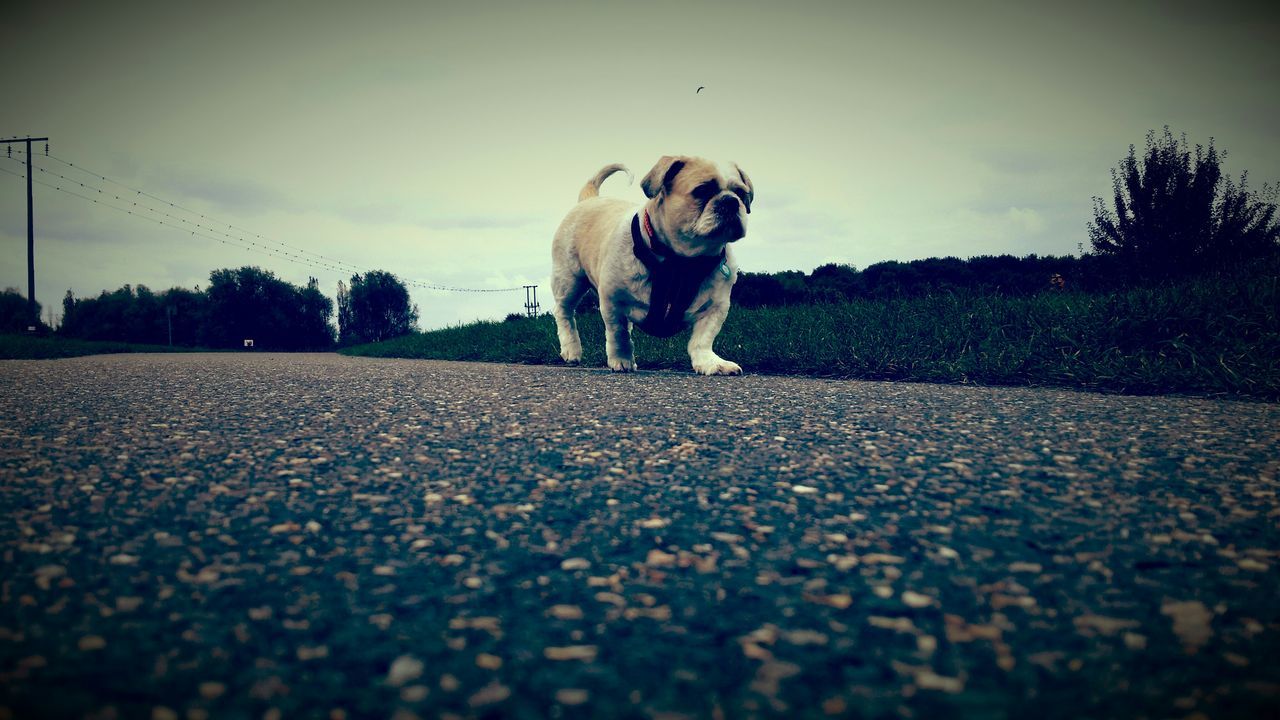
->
xmin=552 ymin=155 xmax=755 ymax=375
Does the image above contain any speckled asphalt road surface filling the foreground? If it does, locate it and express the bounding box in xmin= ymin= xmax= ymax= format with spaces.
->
xmin=0 ymin=355 xmax=1280 ymax=720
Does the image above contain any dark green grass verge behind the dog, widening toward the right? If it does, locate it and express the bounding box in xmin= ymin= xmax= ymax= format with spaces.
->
xmin=342 ymin=271 xmax=1280 ymax=400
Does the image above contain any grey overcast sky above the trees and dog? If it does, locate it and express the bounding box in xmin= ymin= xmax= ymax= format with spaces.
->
xmin=0 ymin=0 xmax=1280 ymax=329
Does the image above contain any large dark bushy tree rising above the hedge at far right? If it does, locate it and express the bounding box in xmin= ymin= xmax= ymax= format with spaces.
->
xmin=1089 ymin=126 xmax=1280 ymax=278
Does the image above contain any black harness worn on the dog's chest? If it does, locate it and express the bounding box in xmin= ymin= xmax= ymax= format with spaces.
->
xmin=631 ymin=213 xmax=724 ymax=337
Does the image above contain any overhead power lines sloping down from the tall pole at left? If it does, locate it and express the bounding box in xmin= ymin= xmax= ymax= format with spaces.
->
xmin=0 ymin=148 xmax=524 ymax=293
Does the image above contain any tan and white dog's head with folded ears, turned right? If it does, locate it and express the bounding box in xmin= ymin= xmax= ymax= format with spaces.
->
xmin=640 ymin=155 xmax=754 ymax=258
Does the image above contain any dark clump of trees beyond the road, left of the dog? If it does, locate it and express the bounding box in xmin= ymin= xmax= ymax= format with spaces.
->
xmin=35 ymin=266 xmax=417 ymax=351
